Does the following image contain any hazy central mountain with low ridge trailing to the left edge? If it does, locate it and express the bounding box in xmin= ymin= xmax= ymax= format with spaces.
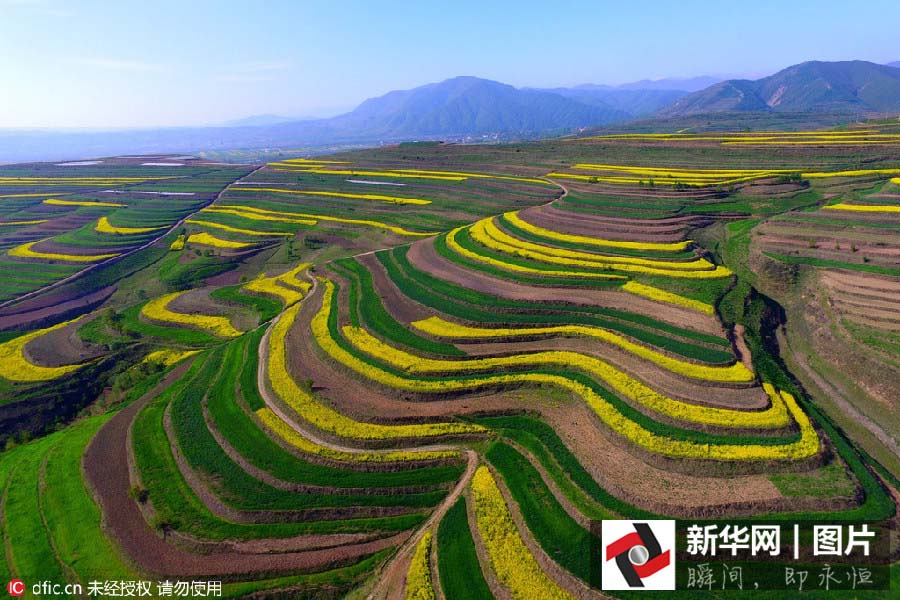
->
xmin=0 ymin=77 xmax=630 ymax=162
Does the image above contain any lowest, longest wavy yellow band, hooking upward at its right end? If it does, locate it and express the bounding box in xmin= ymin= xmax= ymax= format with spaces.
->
xmin=316 ymin=280 xmax=819 ymax=461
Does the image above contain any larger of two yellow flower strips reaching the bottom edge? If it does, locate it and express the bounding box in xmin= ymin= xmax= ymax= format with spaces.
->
xmin=472 ymin=465 xmax=574 ymax=600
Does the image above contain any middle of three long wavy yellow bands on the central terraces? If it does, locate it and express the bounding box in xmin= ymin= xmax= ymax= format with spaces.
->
xmin=343 ymin=325 xmax=790 ymax=428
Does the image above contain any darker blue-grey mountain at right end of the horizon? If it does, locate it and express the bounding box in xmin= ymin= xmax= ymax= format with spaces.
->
xmin=657 ymin=60 xmax=900 ymax=117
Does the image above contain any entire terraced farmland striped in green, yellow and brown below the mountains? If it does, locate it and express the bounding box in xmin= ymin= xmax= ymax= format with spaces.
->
xmin=0 ymin=128 xmax=900 ymax=600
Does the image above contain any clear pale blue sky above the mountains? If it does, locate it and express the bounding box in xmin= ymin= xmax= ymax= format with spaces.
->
xmin=0 ymin=0 xmax=900 ymax=127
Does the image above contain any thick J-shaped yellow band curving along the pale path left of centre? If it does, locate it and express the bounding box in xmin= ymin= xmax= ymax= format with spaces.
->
xmin=267 ymin=296 xmax=485 ymax=440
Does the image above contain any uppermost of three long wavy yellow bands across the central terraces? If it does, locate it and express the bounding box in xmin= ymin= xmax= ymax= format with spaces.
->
xmin=412 ymin=317 xmax=754 ymax=383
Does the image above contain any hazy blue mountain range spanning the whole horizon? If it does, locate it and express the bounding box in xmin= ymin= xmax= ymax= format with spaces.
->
xmin=0 ymin=61 xmax=900 ymax=162
